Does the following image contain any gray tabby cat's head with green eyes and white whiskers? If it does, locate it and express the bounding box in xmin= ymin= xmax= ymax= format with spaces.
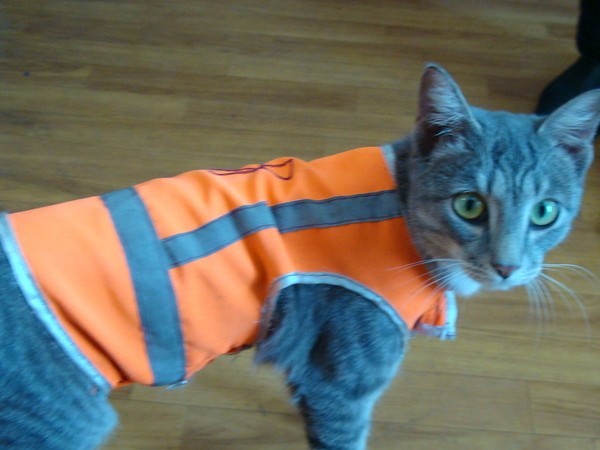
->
xmin=406 ymin=65 xmax=600 ymax=295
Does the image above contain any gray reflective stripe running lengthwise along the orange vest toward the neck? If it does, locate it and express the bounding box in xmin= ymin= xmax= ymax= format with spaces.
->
xmin=163 ymin=190 xmax=401 ymax=267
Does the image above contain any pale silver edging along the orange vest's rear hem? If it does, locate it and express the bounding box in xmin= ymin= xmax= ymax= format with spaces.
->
xmin=0 ymin=213 xmax=110 ymax=392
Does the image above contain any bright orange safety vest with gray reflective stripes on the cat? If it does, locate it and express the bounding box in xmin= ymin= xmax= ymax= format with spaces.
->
xmin=0 ymin=147 xmax=451 ymax=387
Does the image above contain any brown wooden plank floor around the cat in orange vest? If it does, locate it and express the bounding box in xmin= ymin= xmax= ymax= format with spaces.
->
xmin=0 ymin=0 xmax=600 ymax=450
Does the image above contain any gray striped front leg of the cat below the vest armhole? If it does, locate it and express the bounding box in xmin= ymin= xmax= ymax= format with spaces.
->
xmin=257 ymin=285 xmax=405 ymax=450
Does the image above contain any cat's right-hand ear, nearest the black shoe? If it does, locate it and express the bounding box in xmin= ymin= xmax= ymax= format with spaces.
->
xmin=538 ymin=89 xmax=600 ymax=168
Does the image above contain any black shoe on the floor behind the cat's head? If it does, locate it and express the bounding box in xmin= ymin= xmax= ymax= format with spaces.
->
xmin=535 ymin=57 xmax=600 ymax=115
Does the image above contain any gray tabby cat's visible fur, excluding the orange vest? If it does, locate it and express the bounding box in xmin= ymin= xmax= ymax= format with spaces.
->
xmin=0 ymin=66 xmax=600 ymax=450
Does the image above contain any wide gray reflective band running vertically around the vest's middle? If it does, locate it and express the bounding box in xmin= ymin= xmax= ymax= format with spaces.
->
xmin=102 ymin=188 xmax=185 ymax=385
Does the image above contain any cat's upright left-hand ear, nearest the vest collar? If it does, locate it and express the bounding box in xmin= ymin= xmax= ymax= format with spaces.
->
xmin=417 ymin=64 xmax=478 ymax=150
